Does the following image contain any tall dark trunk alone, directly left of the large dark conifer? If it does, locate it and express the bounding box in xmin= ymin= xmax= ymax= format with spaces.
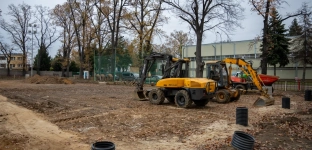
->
xmin=261 ymin=0 xmax=270 ymax=74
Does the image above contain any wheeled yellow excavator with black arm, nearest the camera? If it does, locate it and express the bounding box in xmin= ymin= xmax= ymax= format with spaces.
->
xmin=135 ymin=52 xmax=217 ymax=108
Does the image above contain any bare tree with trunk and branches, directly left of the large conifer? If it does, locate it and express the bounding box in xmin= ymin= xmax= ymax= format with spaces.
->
xmin=249 ymin=0 xmax=302 ymax=74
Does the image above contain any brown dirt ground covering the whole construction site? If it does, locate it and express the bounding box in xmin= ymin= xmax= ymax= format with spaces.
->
xmin=0 ymin=79 xmax=312 ymax=150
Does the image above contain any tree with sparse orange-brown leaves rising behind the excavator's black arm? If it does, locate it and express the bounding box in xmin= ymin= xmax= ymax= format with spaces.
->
xmin=124 ymin=0 xmax=167 ymax=62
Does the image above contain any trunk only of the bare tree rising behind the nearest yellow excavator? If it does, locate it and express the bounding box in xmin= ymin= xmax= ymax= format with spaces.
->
xmin=195 ymin=33 xmax=204 ymax=78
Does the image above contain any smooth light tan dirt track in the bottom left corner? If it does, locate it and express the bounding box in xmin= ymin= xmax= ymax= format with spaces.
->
xmin=0 ymin=95 xmax=89 ymax=149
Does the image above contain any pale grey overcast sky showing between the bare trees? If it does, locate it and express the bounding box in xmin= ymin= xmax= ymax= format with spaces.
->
xmin=0 ymin=0 xmax=311 ymax=57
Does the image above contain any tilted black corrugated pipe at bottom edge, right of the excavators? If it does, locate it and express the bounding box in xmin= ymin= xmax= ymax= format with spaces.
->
xmin=231 ymin=131 xmax=255 ymax=150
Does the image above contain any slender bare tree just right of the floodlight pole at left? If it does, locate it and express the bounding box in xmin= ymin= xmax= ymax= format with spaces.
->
xmin=35 ymin=5 xmax=60 ymax=75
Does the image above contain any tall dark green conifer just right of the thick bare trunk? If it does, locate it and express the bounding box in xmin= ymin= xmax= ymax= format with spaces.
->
xmin=267 ymin=10 xmax=290 ymax=75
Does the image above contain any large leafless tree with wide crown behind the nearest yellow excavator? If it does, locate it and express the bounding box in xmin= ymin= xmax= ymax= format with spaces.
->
xmin=163 ymin=0 xmax=243 ymax=77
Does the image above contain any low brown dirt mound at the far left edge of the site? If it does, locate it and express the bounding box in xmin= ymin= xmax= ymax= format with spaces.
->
xmin=25 ymin=75 xmax=74 ymax=84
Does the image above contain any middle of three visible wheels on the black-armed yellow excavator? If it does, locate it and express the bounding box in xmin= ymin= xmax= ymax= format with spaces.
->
xmin=174 ymin=90 xmax=193 ymax=108
